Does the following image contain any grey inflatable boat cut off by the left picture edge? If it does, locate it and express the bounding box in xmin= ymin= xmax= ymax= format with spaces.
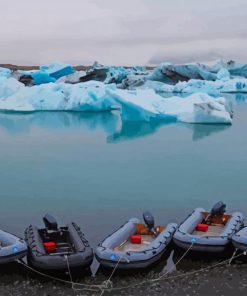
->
xmin=0 ymin=230 xmax=27 ymax=264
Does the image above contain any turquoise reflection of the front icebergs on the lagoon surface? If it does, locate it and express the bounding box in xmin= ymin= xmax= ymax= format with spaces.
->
xmin=0 ymin=112 xmax=230 ymax=143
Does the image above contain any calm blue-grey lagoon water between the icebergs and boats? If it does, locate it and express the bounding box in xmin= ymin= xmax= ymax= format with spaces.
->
xmin=0 ymin=95 xmax=247 ymax=245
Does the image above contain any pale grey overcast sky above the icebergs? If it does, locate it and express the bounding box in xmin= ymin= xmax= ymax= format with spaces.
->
xmin=0 ymin=0 xmax=247 ymax=65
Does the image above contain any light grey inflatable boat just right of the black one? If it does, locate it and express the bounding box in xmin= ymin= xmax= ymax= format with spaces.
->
xmin=95 ymin=212 xmax=177 ymax=269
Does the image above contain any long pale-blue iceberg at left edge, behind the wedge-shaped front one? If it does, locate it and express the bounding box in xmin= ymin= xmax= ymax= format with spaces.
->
xmin=0 ymin=81 xmax=118 ymax=112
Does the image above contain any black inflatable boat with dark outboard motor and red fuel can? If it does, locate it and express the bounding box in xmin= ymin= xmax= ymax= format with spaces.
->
xmin=25 ymin=214 xmax=93 ymax=270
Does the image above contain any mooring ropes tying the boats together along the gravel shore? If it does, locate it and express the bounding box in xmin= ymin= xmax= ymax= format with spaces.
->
xmin=17 ymin=249 xmax=247 ymax=296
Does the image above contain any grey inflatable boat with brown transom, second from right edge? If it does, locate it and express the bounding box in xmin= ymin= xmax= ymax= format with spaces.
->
xmin=173 ymin=202 xmax=244 ymax=253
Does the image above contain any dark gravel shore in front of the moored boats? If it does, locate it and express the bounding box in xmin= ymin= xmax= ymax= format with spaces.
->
xmin=0 ymin=259 xmax=247 ymax=296
